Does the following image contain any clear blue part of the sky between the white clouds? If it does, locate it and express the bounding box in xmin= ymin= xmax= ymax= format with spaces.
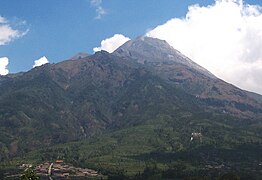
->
xmin=0 ymin=0 xmax=262 ymax=93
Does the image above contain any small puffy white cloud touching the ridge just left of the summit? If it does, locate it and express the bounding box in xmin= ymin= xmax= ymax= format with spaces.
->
xmin=93 ymin=34 xmax=130 ymax=53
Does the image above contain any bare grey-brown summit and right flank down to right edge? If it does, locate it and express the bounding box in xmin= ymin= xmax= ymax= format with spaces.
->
xmin=114 ymin=37 xmax=262 ymax=118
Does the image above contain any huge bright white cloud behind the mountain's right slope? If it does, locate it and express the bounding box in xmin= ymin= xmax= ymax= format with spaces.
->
xmin=147 ymin=0 xmax=262 ymax=94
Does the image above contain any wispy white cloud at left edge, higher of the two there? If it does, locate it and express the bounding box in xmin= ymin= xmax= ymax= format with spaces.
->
xmin=0 ymin=16 xmax=28 ymax=46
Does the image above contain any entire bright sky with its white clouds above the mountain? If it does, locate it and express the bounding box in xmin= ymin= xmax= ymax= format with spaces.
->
xmin=0 ymin=0 xmax=262 ymax=94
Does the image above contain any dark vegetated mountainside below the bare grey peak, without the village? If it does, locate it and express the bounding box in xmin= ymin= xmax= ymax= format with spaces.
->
xmin=0 ymin=38 xmax=262 ymax=179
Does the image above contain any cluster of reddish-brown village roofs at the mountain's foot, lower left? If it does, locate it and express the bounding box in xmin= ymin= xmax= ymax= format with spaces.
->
xmin=20 ymin=160 xmax=102 ymax=179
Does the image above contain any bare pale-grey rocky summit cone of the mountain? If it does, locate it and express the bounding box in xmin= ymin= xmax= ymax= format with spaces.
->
xmin=113 ymin=36 xmax=216 ymax=78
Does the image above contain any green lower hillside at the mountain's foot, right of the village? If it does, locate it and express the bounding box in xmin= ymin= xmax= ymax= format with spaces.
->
xmin=8 ymin=113 xmax=262 ymax=179
